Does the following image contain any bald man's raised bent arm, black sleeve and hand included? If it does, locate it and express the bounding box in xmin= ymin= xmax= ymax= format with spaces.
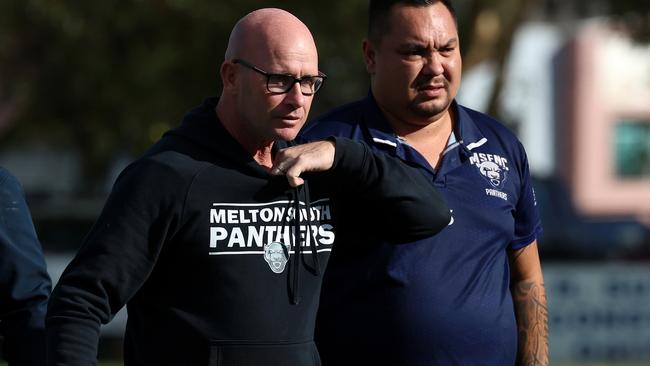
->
xmin=272 ymin=137 xmax=450 ymax=242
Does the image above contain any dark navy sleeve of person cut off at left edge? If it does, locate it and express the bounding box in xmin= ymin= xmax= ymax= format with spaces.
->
xmin=0 ymin=170 xmax=51 ymax=365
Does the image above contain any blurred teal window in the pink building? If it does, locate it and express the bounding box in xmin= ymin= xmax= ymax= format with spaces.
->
xmin=615 ymin=119 xmax=650 ymax=178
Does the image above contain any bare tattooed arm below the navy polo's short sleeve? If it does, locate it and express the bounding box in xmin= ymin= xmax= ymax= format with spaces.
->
xmin=508 ymin=241 xmax=548 ymax=366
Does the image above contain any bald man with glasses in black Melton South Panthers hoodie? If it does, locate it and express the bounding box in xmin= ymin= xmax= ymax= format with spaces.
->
xmin=47 ymin=9 xmax=450 ymax=366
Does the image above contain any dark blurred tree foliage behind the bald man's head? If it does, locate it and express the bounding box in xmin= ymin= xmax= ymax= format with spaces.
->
xmin=0 ymin=0 xmax=365 ymax=194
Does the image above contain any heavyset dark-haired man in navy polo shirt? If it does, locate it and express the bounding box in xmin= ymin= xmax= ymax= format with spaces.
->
xmin=304 ymin=0 xmax=548 ymax=366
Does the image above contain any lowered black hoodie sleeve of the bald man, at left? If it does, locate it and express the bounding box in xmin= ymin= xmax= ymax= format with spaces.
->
xmin=46 ymin=160 xmax=187 ymax=365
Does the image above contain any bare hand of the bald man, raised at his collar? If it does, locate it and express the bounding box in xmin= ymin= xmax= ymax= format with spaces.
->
xmin=271 ymin=141 xmax=336 ymax=187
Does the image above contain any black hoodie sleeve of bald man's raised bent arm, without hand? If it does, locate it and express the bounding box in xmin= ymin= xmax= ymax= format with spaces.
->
xmin=329 ymin=137 xmax=451 ymax=242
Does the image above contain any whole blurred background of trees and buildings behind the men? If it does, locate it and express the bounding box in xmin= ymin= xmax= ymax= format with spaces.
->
xmin=0 ymin=0 xmax=650 ymax=365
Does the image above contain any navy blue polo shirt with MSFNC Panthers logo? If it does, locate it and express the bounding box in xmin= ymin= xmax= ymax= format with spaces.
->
xmin=303 ymin=95 xmax=541 ymax=366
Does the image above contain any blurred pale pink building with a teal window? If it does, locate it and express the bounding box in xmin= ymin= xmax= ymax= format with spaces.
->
xmin=556 ymin=21 xmax=650 ymax=225
